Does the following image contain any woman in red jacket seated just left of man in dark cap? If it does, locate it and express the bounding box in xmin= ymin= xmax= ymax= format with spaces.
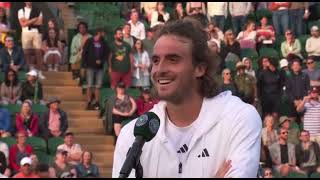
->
xmin=16 ymin=100 xmax=39 ymax=137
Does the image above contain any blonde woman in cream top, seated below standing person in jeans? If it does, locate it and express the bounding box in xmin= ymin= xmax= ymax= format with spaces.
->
xmin=281 ymin=30 xmax=302 ymax=62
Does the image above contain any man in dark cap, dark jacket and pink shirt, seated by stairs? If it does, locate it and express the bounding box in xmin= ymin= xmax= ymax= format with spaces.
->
xmin=40 ymin=97 xmax=68 ymax=139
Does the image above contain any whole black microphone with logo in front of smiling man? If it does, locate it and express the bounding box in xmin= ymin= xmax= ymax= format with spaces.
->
xmin=119 ymin=112 xmax=160 ymax=178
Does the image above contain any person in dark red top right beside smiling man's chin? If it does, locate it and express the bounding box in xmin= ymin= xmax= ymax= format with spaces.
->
xmin=136 ymin=87 xmax=158 ymax=116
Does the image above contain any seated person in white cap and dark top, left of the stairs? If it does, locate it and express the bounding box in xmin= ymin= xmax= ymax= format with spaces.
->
xmin=21 ymin=70 xmax=45 ymax=105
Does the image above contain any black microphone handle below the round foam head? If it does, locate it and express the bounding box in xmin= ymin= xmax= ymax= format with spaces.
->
xmin=119 ymin=136 xmax=145 ymax=178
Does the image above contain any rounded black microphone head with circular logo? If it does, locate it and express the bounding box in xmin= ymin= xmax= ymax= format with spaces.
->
xmin=133 ymin=112 xmax=160 ymax=142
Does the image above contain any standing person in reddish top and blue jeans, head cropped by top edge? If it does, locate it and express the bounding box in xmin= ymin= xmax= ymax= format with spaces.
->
xmin=269 ymin=2 xmax=290 ymax=35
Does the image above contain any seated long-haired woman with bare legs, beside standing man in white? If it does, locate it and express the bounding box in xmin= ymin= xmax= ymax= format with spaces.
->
xmin=42 ymin=29 xmax=63 ymax=72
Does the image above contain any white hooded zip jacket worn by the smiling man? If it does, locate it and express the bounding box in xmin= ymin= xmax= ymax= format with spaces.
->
xmin=112 ymin=91 xmax=262 ymax=178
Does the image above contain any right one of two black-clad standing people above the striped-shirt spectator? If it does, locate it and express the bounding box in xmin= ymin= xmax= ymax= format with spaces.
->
xmin=286 ymin=59 xmax=310 ymax=119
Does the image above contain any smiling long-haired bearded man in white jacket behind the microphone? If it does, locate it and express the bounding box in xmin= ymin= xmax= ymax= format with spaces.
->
xmin=113 ymin=17 xmax=261 ymax=178
